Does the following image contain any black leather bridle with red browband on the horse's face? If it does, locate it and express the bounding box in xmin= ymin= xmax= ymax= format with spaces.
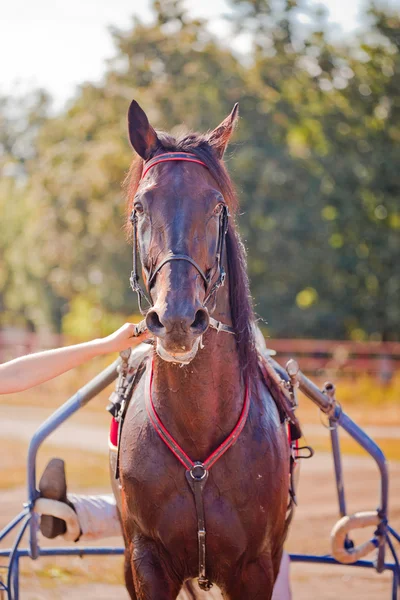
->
xmin=129 ymin=152 xmax=234 ymax=333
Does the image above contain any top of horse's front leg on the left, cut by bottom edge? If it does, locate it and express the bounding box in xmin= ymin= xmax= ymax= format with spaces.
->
xmin=130 ymin=536 xmax=183 ymax=600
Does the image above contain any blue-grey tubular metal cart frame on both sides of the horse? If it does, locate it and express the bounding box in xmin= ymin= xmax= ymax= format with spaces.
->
xmin=0 ymin=359 xmax=400 ymax=600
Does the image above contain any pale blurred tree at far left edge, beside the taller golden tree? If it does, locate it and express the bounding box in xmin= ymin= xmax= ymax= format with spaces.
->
xmin=0 ymin=90 xmax=59 ymax=326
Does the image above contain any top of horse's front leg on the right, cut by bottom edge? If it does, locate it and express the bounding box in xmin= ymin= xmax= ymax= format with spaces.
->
xmin=227 ymin=556 xmax=280 ymax=600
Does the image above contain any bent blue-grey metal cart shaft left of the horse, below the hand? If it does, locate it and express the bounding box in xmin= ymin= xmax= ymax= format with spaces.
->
xmin=28 ymin=358 xmax=121 ymax=559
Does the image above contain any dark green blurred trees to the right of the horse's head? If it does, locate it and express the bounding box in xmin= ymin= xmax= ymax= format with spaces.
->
xmin=225 ymin=0 xmax=400 ymax=339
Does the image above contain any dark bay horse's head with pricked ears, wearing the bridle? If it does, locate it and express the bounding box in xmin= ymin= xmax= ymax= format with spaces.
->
xmin=128 ymin=101 xmax=238 ymax=364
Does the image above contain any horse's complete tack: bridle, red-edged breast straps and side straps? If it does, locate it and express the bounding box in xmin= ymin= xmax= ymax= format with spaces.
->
xmin=108 ymin=152 xmax=301 ymax=591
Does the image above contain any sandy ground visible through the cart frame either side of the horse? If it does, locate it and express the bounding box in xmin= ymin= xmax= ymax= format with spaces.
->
xmin=0 ymin=406 xmax=400 ymax=600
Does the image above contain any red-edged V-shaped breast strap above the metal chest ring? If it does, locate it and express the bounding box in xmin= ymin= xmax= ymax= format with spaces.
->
xmin=146 ymin=364 xmax=250 ymax=471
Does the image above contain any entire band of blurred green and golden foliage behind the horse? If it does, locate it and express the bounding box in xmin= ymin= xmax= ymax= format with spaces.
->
xmin=0 ymin=0 xmax=400 ymax=339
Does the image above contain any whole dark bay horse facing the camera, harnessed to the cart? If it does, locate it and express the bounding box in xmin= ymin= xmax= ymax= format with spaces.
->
xmin=112 ymin=101 xmax=289 ymax=600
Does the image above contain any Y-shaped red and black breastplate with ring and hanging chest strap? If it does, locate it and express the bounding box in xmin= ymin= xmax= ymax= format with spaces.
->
xmin=145 ymin=362 xmax=250 ymax=591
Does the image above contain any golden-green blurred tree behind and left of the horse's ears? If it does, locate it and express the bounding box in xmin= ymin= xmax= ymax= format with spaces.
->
xmin=15 ymin=2 xmax=244 ymax=332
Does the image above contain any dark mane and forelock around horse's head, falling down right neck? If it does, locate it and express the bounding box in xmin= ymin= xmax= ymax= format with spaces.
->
xmin=124 ymin=131 xmax=258 ymax=382
